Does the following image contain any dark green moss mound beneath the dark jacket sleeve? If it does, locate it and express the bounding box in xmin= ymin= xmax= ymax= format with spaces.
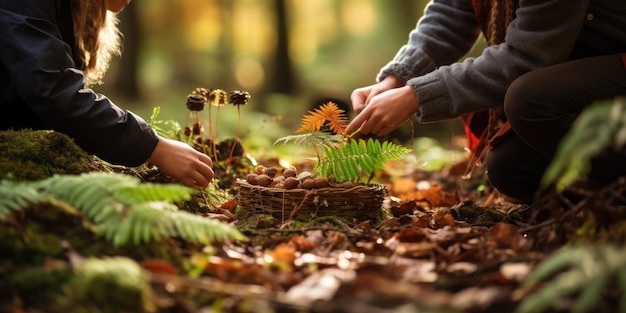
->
xmin=0 ymin=130 xmax=94 ymax=181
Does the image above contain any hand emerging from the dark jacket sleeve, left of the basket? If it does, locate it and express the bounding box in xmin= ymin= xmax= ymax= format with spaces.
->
xmin=147 ymin=137 xmax=214 ymax=188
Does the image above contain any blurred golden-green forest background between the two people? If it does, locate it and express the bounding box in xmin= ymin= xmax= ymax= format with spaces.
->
xmin=95 ymin=0 xmax=482 ymax=168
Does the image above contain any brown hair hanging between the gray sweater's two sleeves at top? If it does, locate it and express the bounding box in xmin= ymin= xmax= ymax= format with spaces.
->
xmin=484 ymin=0 xmax=519 ymax=46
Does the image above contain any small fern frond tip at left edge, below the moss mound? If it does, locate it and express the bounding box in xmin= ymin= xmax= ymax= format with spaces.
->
xmin=0 ymin=181 xmax=43 ymax=220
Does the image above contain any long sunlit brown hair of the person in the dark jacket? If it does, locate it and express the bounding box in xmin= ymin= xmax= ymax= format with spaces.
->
xmin=71 ymin=0 xmax=121 ymax=86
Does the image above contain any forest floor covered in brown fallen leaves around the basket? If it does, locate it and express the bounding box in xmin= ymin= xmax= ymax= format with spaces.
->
xmin=0 ymin=129 xmax=626 ymax=313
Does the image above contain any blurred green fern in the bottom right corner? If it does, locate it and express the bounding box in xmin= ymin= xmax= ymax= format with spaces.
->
xmin=516 ymin=244 xmax=626 ymax=313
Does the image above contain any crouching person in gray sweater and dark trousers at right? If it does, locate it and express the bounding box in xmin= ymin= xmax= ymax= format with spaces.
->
xmin=347 ymin=0 xmax=626 ymax=203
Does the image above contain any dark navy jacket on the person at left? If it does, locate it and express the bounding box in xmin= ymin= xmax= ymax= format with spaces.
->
xmin=0 ymin=0 xmax=158 ymax=166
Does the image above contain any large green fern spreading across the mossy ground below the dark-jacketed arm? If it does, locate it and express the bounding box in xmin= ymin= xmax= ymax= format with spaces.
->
xmin=0 ymin=173 xmax=245 ymax=246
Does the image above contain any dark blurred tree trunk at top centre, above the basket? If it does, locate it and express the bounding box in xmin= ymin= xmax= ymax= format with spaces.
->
xmin=267 ymin=0 xmax=297 ymax=94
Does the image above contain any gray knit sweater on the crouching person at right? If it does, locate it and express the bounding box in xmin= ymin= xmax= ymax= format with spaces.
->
xmin=377 ymin=0 xmax=626 ymax=123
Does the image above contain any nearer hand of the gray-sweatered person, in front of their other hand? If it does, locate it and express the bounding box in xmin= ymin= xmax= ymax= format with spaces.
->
xmin=346 ymin=86 xmax=419 ymax=136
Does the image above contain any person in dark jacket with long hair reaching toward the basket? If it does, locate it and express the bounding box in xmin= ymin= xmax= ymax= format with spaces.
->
xmin=0 ymin=0 xmax=213 ymax=188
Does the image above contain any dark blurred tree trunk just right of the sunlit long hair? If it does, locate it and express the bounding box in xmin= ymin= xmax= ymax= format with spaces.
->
xmin=113 ymin=3 xmax=141 ymax=99
